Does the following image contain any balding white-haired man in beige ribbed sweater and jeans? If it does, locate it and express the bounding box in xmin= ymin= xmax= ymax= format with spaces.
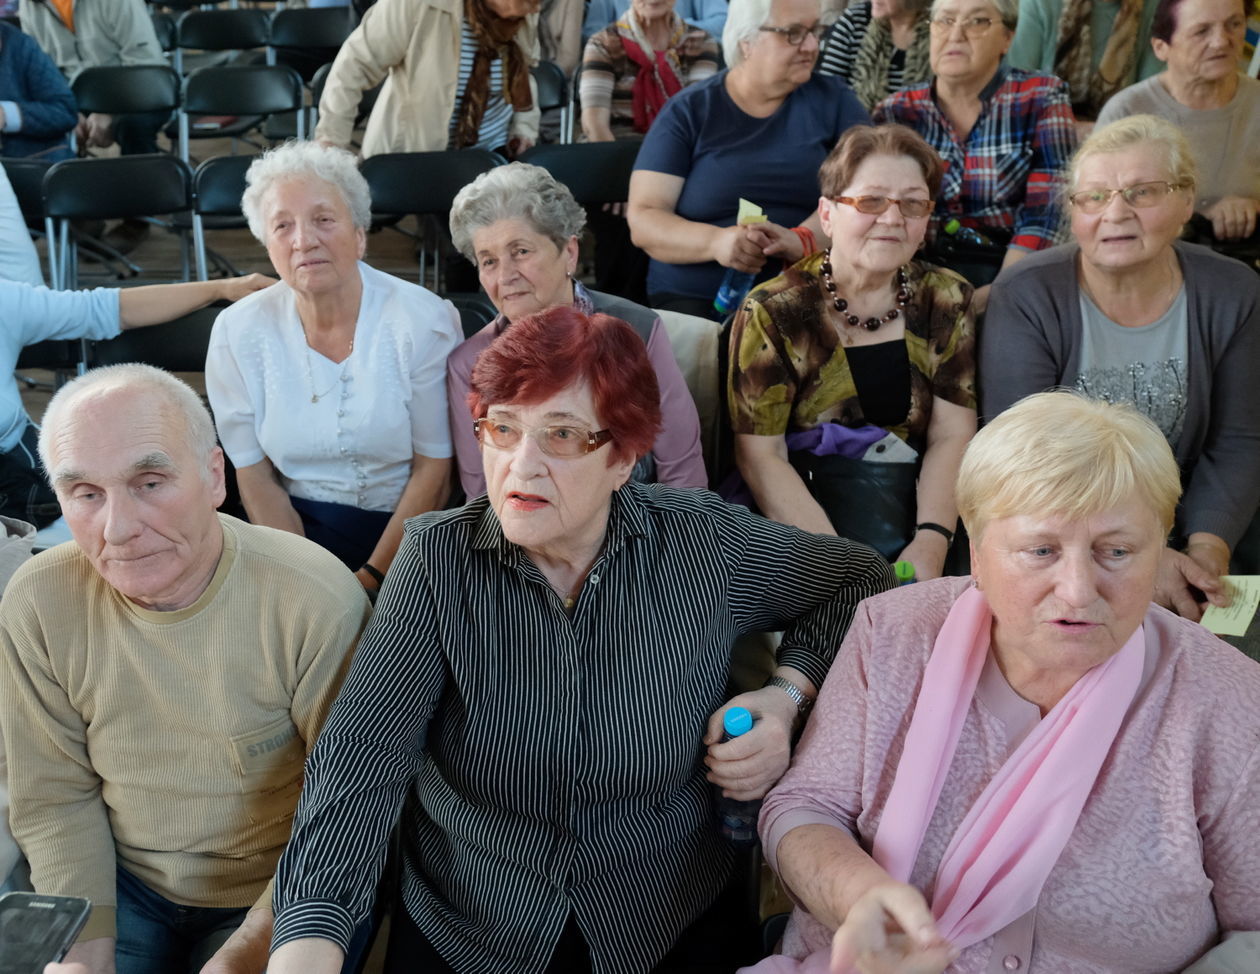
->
xmin=0 ymin=365 xmax=368 ymax=974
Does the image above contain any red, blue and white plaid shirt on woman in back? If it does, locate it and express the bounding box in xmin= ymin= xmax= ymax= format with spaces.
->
xmin=872 ymin=68 xmax=1076 ymax=251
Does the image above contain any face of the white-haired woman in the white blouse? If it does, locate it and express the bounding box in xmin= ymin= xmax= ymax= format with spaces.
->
xmin=262 ymin=176 xmax=367 ymax=297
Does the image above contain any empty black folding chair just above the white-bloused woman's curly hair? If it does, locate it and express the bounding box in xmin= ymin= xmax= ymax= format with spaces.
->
xmin=179 ymin=64 xmax=306 ymax=163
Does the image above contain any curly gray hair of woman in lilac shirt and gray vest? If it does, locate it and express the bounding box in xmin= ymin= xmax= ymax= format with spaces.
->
xmin=451 ymin=163 xmax=586 ymax=263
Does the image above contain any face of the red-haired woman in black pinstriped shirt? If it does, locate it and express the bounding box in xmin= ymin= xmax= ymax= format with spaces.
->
xmin=481 ymin=383 xmax=634 ymax=553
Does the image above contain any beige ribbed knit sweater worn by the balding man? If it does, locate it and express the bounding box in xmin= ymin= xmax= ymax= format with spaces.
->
xmin=0 ymin=515 xmax=368 ymax=939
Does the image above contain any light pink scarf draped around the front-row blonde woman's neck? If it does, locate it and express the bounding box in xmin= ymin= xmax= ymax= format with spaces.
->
xmin=746 ymin=588 xmax=1145 ymax=974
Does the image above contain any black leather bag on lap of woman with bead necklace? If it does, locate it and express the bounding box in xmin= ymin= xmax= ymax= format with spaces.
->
xmin=790 ymin=451 xmax=919 ymax=562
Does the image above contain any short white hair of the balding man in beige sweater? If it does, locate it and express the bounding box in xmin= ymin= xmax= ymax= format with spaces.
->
xmin=39 ymin=362 xmax=218 ymax=480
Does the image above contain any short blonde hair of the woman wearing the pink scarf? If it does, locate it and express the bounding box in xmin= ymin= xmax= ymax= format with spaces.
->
xmin=955 ymin=389 xmax=1181 ymax=542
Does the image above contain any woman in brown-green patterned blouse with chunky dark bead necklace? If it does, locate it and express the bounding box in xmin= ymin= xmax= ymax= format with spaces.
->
xmin=728 ymin=125 xmax=977 ymax=578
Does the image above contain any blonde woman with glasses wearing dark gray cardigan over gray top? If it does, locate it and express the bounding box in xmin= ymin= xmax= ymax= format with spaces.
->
xmin=977 ymin=115 xmax=1260 ymax=619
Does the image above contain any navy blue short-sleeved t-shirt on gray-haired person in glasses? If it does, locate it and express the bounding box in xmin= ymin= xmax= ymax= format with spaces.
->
xmin=634 ymin=71 xmax=871 ymax=297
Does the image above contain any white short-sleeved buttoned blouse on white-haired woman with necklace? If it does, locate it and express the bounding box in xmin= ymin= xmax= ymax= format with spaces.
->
xmin=205 ymin=262 xmax=462 ymax=512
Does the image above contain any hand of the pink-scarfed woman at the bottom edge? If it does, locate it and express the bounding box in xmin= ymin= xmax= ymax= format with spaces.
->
xmin=832 ymin=882 xmax=959 ymax=974
